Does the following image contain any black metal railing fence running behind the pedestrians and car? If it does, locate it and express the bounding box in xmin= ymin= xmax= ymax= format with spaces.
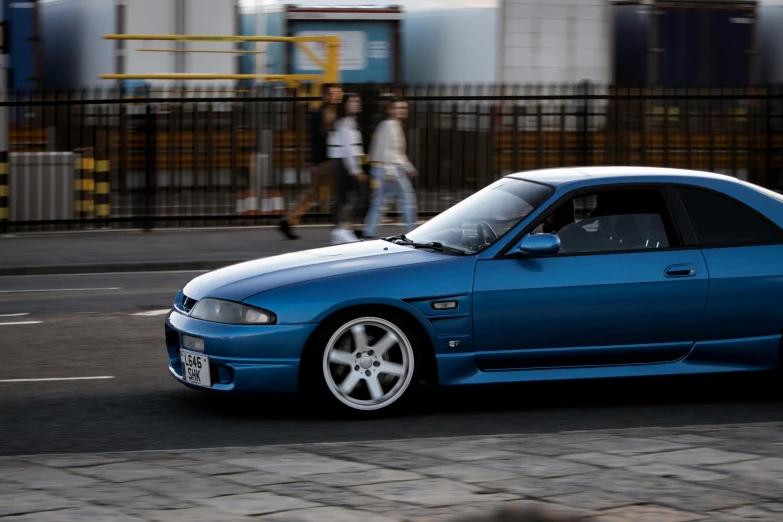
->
xmin=0 ymin=84 xmax=783 ymax=232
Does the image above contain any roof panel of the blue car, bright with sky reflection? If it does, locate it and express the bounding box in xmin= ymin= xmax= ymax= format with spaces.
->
xmin=507 ymin=166 xmax=737 ymax=185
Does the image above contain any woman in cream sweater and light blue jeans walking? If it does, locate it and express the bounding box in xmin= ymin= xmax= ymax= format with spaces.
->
xmin=363 ymin=98 xmax=418 ymax=239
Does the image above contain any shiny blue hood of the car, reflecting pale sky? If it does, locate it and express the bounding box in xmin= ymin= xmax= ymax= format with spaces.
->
xmin=182 ymin=240 xmax=451 ymax=301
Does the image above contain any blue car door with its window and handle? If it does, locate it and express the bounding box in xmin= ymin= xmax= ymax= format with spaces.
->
xmin=473 ymin=187 xmax=709 ymax=370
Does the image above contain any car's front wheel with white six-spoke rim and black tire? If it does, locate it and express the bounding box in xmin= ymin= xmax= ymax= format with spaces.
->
xmin=301 ymin=310 xmax=420 ymax=419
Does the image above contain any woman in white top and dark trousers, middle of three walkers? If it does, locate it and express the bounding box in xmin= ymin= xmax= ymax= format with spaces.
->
xmin=327 ymin=93 xmax=366 ymax=244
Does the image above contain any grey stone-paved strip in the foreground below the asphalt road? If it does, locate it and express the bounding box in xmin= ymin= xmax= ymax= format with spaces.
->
xmin=0 ymin=423 xmax=783 ymax=522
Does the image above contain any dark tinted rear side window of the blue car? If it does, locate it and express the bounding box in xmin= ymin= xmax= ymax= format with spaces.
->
xmin=677 ymin=187 xmax=783 ymax=248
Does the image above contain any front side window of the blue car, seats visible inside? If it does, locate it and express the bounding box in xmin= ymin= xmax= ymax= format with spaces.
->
xmin=534 ymin=188 xmax=680 ymax=254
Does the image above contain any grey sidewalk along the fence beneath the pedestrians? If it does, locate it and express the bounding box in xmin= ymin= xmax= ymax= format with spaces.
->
xmin=0 ymin=226 xmax=401 ymax=276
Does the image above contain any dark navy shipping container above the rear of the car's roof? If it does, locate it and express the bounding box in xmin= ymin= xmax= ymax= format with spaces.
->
xmin=613 ymin=0 xmax=759 ymax=87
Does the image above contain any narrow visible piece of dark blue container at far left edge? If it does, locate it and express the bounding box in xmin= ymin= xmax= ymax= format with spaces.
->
xmin=3 ymin=0 xmax=41 ymax=91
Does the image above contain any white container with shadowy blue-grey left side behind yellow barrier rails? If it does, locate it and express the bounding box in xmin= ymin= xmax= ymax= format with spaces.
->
xmin=41 ymin=0 xmax=239 ymax=88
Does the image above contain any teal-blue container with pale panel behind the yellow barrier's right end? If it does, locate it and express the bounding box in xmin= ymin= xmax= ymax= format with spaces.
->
xmin=265 ymin=5 xmax=403 ymax=83
